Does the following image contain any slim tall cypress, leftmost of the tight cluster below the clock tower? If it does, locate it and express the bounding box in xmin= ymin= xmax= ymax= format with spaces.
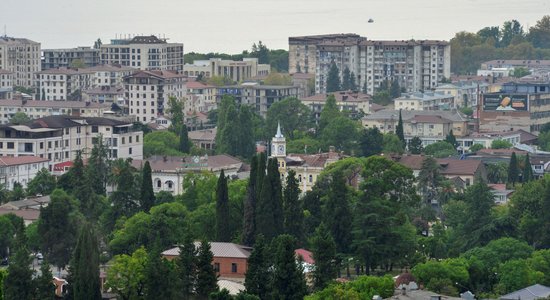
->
xmin=241 ymin=155 xmax=258 ymax=246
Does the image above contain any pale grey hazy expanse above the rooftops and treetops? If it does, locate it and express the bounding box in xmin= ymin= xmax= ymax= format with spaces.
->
xmin=0 ymin=0 xmax=550 ymax=53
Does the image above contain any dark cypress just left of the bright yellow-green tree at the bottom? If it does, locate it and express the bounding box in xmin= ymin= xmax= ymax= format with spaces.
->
xmin=72 ymin=224 xmax=101 ymax=300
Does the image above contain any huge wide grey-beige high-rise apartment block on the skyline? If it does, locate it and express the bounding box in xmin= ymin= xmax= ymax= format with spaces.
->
xmin=289 ymin=34 xmax=451 ymax=95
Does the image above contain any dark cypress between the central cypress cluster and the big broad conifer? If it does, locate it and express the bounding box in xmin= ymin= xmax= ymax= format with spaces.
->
xmin=324 ymin=171 xmax=352 ymax=253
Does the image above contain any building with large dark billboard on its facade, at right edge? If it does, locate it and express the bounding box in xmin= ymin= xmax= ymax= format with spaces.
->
xmin=479 ymin=82 xmax=550 ymax=133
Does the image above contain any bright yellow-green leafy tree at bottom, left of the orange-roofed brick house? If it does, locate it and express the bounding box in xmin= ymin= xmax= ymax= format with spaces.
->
xmin=105 ymin=247 xmax=147 ymax=300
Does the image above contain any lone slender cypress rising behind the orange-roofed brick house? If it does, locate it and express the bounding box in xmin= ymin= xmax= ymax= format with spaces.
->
xmin=216 ymin=170 xmax=231 ymax=242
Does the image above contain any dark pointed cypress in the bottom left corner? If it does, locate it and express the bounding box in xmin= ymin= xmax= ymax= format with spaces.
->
xmin=4 ymin=228 xmax=33 ymax=300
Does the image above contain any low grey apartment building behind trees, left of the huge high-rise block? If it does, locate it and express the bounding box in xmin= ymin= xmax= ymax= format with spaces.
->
xmin=217 ymin=82 xmax=299 ymax=117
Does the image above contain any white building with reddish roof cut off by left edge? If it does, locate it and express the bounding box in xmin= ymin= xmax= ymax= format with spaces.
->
xmin=0 ymin=156 xmax=49 ymax=190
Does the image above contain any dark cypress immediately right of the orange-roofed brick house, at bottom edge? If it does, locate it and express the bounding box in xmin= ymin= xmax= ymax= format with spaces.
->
xmin=244 ymin=234 xmax=270 ymax=299
